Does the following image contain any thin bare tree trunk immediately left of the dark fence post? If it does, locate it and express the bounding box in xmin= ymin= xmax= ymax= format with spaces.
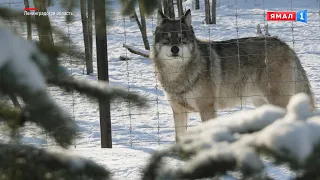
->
xmin=80 ymin=0 xmax=93 ymax=74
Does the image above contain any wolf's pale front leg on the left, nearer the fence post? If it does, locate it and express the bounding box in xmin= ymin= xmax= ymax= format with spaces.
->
xmin=170 ymin=102 xmax=188 ymax=142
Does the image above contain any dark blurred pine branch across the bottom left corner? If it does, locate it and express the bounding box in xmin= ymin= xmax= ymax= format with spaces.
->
xmin=0 ymin=144 xmax=110 ymax=180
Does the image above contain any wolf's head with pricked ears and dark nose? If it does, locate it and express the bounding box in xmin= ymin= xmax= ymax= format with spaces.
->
xmin=153 ymin=9 xmax=196 ymax=63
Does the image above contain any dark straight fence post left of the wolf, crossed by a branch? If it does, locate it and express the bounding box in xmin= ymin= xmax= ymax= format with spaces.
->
xmin=94 ymin=0 xmax=112 ymax=148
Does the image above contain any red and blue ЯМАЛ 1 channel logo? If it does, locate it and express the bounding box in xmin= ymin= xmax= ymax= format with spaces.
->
xmin=267 ymin=10 xmax=308 ymax=23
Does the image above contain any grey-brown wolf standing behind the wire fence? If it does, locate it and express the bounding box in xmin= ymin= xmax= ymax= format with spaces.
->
xmin=150 ymin=9 xmax=314 ymax=140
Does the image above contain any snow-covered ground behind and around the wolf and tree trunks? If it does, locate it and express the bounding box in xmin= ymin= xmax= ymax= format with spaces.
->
xmin=0 ymin=0 xmax=320 ymax=179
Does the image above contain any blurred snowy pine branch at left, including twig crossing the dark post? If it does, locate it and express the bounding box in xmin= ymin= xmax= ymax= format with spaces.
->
xmin=0 ymin=14 xmax=146 ymax=147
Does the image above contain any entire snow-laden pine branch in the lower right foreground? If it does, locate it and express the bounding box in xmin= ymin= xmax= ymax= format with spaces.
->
xmin=144 ymin=93 xmax=320 ymax=179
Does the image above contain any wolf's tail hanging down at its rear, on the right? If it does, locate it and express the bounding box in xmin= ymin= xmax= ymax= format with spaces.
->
xmin=292 ymin=51 xmax=316 ymax=108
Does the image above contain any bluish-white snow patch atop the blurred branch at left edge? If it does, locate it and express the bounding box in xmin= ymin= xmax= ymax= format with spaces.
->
xmin=0 ymin=19 xmax=48 ymax=91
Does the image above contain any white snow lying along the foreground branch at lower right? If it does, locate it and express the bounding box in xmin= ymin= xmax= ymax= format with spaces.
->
xmin=152 ymin=93 xmax=320 ymax=177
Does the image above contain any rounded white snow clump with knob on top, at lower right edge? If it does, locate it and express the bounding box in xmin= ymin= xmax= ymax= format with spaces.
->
xmin=254 ymin=94 xmax=320 ymax=164
